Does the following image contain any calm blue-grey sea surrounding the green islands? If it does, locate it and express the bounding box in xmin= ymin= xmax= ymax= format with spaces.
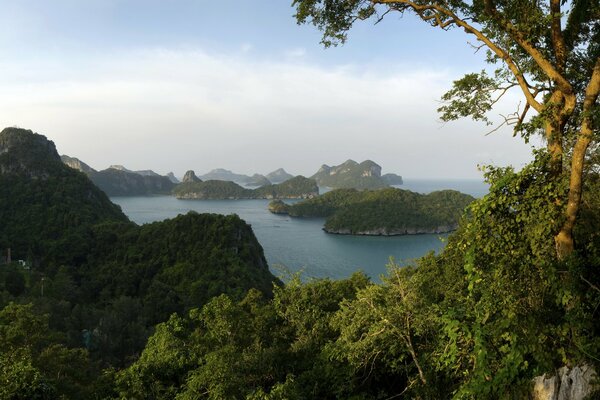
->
xmin=111 ymin=179 xmax=488 ymax=282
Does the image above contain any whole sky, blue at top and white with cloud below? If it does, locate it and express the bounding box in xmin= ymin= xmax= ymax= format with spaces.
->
xmin=0 ymin=0 xmax=531 ymax=179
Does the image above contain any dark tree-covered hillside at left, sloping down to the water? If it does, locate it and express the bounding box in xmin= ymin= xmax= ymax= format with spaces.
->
xmin=0 ymin=128 xmax=277 ymax=399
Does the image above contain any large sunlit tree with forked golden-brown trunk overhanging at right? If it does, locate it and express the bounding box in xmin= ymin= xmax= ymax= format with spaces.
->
xmin=293 ymin=0 xmax=600 ymax=258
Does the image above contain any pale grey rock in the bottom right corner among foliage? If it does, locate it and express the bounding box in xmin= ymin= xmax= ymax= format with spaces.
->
xmin=532 ymin=365 xmax=598 ymax=400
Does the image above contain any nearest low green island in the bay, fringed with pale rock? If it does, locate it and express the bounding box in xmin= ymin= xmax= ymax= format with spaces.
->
xmin=268 ymin=188 xmax=474 ymax=236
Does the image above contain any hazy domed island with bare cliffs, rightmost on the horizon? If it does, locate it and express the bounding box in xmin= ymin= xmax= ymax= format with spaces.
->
xmin=311 ymin=160 xmax=402 ymax=190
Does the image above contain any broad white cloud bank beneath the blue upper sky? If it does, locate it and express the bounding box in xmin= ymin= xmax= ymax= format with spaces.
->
xmin=0 ymin=49 xmax=529 ymax=178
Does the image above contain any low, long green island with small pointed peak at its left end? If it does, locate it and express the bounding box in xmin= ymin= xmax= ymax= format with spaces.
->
xmin=173 ymin=175 xmax=319 ymax=200
